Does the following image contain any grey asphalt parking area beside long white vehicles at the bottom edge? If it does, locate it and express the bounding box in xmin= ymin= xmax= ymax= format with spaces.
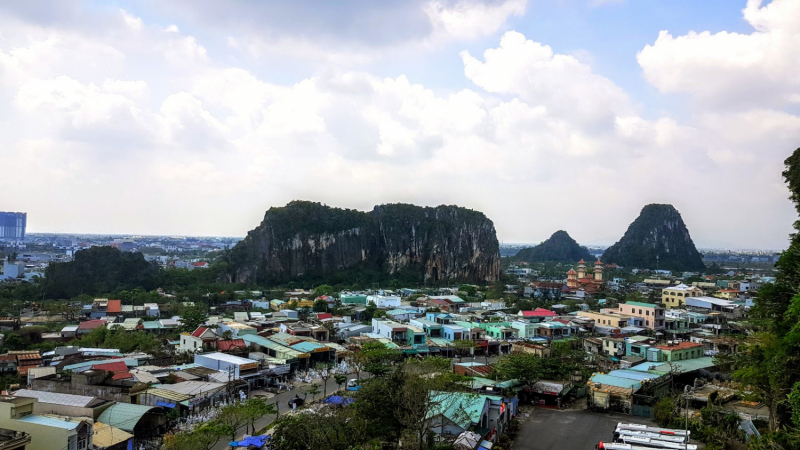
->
xmin=512 ymin=408 xmax=655 ymax=450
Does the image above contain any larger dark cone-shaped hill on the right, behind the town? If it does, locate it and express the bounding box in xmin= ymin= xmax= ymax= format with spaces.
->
xmin=603 ymin=204 xmax=705 ymax=271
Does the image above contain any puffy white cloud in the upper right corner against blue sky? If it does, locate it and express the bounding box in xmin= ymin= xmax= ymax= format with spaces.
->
xmin=637 ymin=0 xmax=800 ymax=109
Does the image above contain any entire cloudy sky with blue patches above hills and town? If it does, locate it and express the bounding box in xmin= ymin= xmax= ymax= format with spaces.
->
xmin=0 ymin=0 xmax=800 ymax=249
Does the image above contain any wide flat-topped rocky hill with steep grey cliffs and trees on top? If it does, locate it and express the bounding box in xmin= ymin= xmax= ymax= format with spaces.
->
xmin=228 ymin=201 xmax=500 ymax=283
